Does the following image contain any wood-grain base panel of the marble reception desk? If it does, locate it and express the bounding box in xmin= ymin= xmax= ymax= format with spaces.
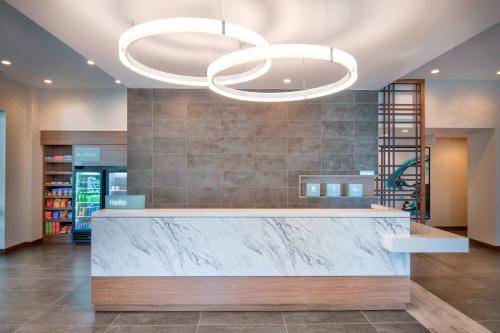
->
xmin=92 ymin=276 xmax=410 ymax=311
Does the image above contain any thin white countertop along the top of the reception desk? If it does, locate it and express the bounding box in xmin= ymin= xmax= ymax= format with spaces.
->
xmin=92 ymin=205 xmax=410 ymax=218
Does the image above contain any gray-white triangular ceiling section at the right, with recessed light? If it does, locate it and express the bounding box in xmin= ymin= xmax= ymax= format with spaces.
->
xmin=407 ymin=23 xmax=500 ymax=80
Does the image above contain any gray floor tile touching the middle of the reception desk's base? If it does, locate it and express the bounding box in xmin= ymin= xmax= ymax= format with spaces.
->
xmin=200 ymin=312 xmax=284 ymax=325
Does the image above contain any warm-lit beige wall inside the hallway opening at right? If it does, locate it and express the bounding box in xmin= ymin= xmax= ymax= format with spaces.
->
xmin=427 ymin=137 xmax=467 ymax=227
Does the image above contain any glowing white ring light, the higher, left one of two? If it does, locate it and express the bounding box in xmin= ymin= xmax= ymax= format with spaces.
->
xmin=118 ymin=17 xmax=271 ymax=87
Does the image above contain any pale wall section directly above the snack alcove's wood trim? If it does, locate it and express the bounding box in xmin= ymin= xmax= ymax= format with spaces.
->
xmin=39 ymin=89 xmax=127 ymax=131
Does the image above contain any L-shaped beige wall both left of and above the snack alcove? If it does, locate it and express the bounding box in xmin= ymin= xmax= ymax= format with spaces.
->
xmin=0 ymin=77 xmax=127 ymax=247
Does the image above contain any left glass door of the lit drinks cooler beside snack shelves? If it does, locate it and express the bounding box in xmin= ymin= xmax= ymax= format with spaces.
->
xmin=74 ymin=171 xmax=102 ymax=231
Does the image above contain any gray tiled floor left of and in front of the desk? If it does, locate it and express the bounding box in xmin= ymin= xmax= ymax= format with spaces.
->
xmin=0 ymin=241 xmax=428 ymax=333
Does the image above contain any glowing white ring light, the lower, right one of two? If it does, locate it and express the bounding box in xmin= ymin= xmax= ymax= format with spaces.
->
xmin=207 ymin=44 xmax=358 ymax=102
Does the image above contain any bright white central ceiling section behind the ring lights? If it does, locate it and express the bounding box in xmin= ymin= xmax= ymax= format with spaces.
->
xmin=3 ymin=0 xmax=500 ymax=89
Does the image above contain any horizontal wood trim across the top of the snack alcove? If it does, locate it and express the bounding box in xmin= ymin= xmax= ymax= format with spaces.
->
xmin=40 ymin=131 xmax=127 ymax=145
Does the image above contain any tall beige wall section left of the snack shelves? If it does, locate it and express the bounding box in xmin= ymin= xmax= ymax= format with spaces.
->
xmin=0 ymin=77 xmax=42 ymax=247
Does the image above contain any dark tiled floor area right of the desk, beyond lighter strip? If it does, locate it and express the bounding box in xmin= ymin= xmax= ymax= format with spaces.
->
xmin=412 ymin=245 xmax=500 ymax=333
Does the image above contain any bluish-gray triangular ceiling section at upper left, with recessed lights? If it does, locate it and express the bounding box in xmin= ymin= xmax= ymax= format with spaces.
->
xmin=0 ymin=1 xmax=117 ymax=89
